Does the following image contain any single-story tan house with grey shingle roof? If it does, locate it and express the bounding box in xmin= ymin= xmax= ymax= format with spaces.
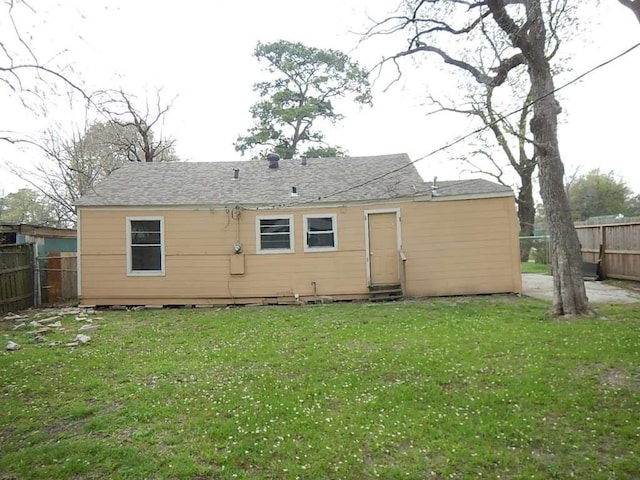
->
xmin=77 ymin=154 xmax=521 ymax=305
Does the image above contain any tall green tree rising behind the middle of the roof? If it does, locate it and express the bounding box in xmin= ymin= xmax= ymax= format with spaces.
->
xmin=234 ymin=40 xmax=371 ymax=158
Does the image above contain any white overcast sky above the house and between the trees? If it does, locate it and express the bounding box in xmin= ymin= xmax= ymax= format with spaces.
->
xmin=0 ymin=0 xmax=640 ymax=193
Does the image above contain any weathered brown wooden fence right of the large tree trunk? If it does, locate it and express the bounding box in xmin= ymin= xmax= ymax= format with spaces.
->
xmin=576 ymin=219 xmax=640 ymax=281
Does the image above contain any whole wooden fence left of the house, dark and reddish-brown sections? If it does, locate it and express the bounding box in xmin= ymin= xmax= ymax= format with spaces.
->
xmin=0 ymin=244 xmax=78 ymax=314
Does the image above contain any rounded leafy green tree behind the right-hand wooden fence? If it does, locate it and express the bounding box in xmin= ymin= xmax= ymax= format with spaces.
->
xmin=566 ymin=169 xmax=634 ymax=220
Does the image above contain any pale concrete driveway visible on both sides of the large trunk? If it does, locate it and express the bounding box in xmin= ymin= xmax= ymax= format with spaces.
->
xmin=522 ymin=273 xmax=640 ymax=304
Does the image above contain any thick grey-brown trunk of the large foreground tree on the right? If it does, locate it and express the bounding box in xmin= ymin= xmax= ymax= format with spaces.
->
xmin=521 ymin=0 xmax=589 ymax=315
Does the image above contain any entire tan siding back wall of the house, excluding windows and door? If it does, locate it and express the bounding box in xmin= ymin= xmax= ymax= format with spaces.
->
xmin=78 ymin=197 xmax=521 ymax=305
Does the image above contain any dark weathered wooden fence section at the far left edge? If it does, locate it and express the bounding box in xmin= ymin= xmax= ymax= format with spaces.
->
xmin=0 ymin=244 xmax=34 ymax=313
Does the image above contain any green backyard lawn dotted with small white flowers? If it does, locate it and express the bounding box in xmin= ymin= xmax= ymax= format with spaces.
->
xmin=0 ymin=296 xmax=640 ymax=479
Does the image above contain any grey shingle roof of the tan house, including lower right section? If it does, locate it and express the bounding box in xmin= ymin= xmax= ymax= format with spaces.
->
xmin=76 ymin=154 xmax=511 ymax=206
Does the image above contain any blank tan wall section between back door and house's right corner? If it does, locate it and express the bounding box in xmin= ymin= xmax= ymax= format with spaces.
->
xmin=402 ymin=197 xmax=522 ymax=296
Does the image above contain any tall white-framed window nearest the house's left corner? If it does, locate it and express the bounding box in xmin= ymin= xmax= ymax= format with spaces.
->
xmin=127 ymin=217 xmax=164 ymax=276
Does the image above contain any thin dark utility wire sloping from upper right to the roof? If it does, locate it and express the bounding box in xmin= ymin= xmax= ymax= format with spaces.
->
xmin=283 ymin=42 xmax=640 ymax=206
